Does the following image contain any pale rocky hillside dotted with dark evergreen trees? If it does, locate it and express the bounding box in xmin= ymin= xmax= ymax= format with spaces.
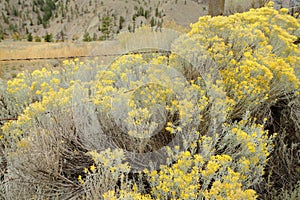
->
xmin=0 ymin=0 xmax=300 ymax=41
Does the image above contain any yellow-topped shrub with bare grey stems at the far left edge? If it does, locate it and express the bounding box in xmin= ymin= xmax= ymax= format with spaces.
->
xmin=1 ymin=61 xmax=105 ymax=199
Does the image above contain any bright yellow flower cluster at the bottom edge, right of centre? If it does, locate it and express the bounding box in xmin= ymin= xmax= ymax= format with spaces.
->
xmin=149 ymin=145 xmax=257 ymax=199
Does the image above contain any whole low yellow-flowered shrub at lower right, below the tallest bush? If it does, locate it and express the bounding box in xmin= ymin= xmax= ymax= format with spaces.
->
xmin=146 ymin=118 xmax=272 ymax=199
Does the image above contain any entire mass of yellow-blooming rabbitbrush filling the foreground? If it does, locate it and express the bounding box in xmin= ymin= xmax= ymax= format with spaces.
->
xmin=0 ymin=3 xmax=300 ymax=199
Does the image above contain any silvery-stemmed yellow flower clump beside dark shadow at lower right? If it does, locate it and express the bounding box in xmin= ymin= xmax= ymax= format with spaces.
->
xmin=219 ymin=120 xmax=272 ymax=186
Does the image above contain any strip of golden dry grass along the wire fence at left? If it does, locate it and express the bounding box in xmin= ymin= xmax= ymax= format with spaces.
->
xmin=0 ymin=41 xmax=121 ymax=80
